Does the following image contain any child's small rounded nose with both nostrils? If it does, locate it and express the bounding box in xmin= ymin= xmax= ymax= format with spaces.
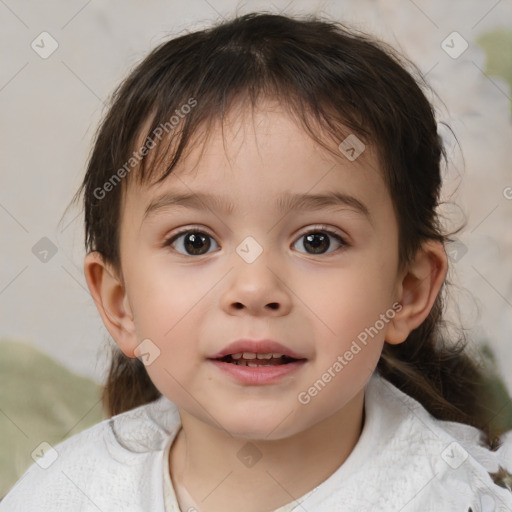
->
xmin=222 ymin=253 xmax=292 ymax=316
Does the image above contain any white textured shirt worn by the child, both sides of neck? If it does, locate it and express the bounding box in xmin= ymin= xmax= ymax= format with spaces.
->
xmin=0 ymin=373 xmax=512 ymax=512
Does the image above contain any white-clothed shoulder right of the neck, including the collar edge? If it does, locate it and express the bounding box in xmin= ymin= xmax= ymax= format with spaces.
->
xmin=264 ymin=373 xmax=512 ymax=512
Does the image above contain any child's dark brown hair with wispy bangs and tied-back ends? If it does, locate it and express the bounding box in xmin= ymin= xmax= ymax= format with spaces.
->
xmin=68 ymin=13 xmax=508 ymax=448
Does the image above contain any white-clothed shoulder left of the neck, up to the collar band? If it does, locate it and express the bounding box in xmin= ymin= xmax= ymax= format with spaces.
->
xmin=0 ymin=397 xmax=179 ymax=512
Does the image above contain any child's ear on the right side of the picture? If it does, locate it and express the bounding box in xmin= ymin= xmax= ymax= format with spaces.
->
xmin=386 ymin=240 xmax=448 ymax=345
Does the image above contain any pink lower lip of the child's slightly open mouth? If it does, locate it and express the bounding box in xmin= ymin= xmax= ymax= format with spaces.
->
xmin=209 ymin=359 xmax=306 ymax=386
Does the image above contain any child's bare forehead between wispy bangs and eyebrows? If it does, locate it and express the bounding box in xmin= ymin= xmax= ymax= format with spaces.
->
xmin=121 ymin=103 xmax=386 ymax=225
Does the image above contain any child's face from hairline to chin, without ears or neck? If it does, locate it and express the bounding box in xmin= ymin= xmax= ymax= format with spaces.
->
xmin=116 ymin=104 xmax=400 ymax=440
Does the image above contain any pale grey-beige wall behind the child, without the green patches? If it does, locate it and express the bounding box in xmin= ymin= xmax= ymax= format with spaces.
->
xmin=0 ymin=0 xmax=512 ymax=391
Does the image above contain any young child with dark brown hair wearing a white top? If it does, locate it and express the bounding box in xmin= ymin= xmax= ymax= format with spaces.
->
xmin=0 ymin=10 xmax=512 ymax=512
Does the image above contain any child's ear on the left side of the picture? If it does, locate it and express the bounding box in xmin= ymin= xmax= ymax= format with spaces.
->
xmin=84 ymin=251 xmax=137 ymax=358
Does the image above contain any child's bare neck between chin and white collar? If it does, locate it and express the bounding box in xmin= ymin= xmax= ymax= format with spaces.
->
xmin=169 ymin=390 xmax=364 ymax=512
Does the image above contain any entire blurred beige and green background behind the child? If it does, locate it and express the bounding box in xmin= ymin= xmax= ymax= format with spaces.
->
xmin=0 ymin=0 xmax=512 ymax=497
